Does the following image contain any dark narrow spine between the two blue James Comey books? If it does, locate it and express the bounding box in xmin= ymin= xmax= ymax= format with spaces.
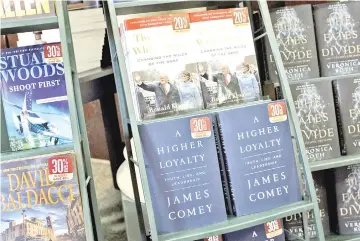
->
xmin=213 ymin=115 xmax=233 ymax=215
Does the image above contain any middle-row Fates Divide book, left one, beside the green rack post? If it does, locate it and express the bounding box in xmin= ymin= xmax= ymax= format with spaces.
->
xmin=290 ymin=81 xmax=340 ymax=161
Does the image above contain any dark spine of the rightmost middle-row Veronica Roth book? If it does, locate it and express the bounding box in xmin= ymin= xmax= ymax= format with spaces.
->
xmin=332 ymin=80 xmax=346 ymax=155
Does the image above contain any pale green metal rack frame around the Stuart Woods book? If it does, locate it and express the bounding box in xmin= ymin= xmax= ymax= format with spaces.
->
xmin=0 ymin=0 xmax=103 ymax=241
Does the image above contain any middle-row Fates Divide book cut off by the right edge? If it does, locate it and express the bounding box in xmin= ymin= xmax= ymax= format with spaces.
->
xmin=333 ymin=78 xmax=360 ymax=154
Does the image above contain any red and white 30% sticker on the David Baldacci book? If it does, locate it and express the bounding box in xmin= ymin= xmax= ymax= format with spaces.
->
xmin=48 ymin=156 xmax=74 ymax=182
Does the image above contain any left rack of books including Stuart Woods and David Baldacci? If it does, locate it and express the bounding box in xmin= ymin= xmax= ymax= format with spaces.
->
xmin=0 ymin=0 xmax=102 ymax=241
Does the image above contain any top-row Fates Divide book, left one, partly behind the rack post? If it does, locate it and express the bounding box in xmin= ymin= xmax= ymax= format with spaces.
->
xmin=265 ymin=4 xmax=320 ymax=82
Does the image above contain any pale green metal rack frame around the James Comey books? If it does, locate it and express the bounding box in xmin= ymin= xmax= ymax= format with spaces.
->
xmin=104 ymin=0 xmax=360 ymax=241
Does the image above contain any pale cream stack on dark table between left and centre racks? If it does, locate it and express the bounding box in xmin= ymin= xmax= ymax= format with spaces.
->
xmin=69 ymin=8 xmax=106 ymax=73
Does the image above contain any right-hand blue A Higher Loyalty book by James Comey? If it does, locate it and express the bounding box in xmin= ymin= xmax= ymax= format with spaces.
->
xmin=217 ymin=101 xmax=302 ymax=216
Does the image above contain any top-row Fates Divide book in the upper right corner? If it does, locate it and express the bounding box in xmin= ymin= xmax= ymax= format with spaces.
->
xmin=314 ymin=1 xmax=360 ymax=76
